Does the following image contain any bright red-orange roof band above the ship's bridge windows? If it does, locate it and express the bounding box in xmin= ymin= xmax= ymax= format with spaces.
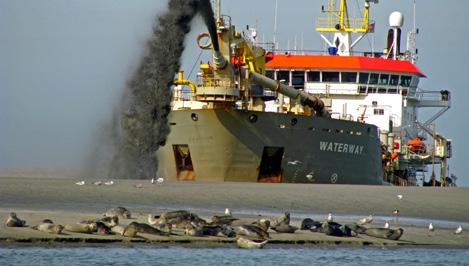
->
xmin=266 ymin=54 xmax=425 ymax=77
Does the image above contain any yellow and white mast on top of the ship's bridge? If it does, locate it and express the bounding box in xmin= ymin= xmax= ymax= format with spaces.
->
xmin=316 ymin=0 xmax=378 ymax=56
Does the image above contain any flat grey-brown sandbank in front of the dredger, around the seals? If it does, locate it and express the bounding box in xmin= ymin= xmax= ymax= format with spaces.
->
xmin=0 ymin=177 xmax=469 ymax=247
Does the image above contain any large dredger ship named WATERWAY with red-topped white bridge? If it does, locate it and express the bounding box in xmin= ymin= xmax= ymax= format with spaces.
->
xmin=158 ymin=0 xmax=451 ymax=185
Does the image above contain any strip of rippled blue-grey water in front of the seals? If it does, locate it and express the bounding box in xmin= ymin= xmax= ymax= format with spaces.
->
xmin=0 ymin=246 xmax=469 ymax=266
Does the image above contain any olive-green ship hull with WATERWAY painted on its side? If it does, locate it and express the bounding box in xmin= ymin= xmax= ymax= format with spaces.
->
xmin=158 ymin=109 xmax=383 ymax=185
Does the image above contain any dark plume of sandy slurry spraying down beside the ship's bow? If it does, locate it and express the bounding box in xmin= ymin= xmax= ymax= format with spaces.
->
xmin=103 ymin=0 xmax=218 ymax=179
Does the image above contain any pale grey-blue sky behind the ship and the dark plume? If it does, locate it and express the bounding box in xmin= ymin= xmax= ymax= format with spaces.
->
xmin=0 ymin=0 xmax=469 ymax=186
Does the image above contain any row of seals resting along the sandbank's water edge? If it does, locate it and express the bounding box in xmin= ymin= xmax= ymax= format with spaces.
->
xmin=1 ymin=207 xmax=404 ymax=244
